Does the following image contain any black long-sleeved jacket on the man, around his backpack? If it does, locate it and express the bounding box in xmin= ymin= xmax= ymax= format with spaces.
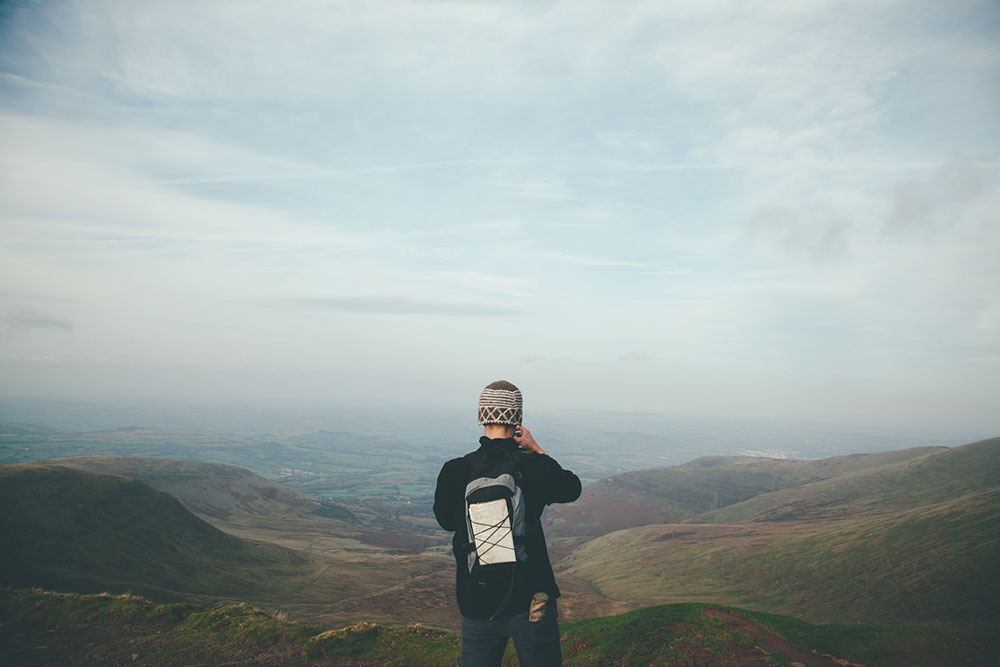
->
xmin=434 ymin=436 xmax=580 ymax=619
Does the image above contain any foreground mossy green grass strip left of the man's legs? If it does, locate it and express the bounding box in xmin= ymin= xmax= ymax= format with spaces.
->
xmin=0 ymin=589 xmax=459 ymax=667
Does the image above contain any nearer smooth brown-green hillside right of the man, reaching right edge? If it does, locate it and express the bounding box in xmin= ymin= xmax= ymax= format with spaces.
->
xmin=560 ymin=489 xmax=1000 ymax=623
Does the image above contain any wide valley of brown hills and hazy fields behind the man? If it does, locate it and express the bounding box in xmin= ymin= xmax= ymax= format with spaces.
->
xmin=0 ymin=404 xmax=1000 ymax=667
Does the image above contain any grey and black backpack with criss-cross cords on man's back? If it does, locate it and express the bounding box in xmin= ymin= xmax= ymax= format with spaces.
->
xmin=463 ymin=448 xmax=528 ymax=573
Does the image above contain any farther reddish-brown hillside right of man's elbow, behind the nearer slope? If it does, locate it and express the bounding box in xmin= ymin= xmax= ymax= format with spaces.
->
xmin=547 ymin=447 xmax=947 ymax=537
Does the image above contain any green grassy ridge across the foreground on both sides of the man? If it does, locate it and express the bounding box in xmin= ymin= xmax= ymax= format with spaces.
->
xmin=0 ymin=590 xmax=1000 ymax=667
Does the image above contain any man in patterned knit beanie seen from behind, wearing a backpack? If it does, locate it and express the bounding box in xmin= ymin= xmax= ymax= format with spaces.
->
xmin=434 ymin=380 xmax=580 ymax=667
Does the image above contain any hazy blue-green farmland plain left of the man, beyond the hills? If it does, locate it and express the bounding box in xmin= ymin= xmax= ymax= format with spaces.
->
xmin=0 ymin=425 xmax=446 ymax=530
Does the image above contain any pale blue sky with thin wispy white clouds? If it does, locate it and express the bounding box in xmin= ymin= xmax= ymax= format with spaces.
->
xmin=0 ymin=0 xmax=1000 ymax=434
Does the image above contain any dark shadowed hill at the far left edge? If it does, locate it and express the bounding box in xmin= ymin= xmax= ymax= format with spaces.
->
xmin=0 ymin=464 xmax=311 ymax=600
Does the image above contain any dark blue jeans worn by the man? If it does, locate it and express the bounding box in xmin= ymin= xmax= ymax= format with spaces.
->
xmin=462 ymin=600 xmax=562 ymax=667
